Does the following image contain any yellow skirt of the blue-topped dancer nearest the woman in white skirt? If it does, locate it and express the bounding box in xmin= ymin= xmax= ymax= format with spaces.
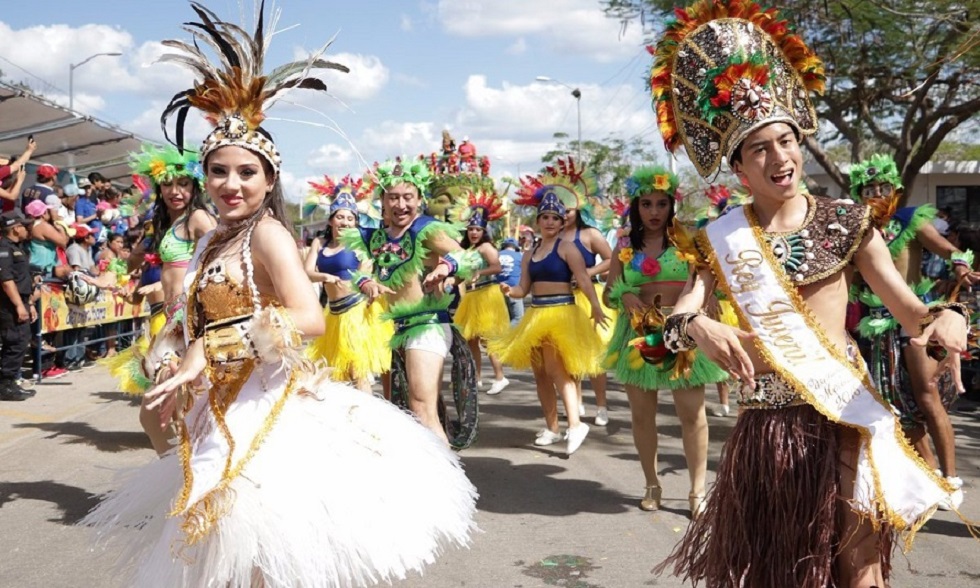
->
xmin=306 ymin=300 xmax=395 ymax=382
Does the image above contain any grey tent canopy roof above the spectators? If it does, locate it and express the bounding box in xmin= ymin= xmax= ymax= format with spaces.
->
xmin=0 ymin=82 xmax=154 ymax=184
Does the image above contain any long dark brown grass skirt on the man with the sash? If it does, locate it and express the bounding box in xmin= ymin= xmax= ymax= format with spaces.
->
xmin=655 ymin=405 xmax=891 ymax=588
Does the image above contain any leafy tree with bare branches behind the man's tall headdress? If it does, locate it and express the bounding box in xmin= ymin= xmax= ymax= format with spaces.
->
xmin=600 ymin=0 xmax=980 ymax=203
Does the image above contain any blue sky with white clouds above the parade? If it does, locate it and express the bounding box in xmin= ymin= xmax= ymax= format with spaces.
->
xmin=0 ymin=0 xmax=660 ymax=199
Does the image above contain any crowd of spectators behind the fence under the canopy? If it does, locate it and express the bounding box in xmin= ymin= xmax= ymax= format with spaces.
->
xmin=0 ymin=138 xmax=152 ymax=388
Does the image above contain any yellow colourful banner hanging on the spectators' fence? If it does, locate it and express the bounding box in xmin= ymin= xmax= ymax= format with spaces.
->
xmin=40 ymin=283 xmax=150 ymax=333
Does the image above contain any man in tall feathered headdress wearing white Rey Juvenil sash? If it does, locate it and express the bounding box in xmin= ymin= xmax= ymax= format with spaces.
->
xmin=651 ymin=0 xmax=967 ymax=587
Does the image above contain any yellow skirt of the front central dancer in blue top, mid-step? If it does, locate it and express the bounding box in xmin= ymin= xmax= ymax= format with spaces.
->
xmin=488 ymin=304 xmax=605 ymax=378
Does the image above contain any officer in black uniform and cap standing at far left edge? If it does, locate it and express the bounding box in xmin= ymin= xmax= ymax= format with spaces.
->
xmin=0 ymin=211 xmax=37 ymax=400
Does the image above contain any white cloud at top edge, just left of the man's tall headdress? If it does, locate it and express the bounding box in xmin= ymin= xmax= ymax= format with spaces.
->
xmin=438 ymin=0 xmax=643 ymax=62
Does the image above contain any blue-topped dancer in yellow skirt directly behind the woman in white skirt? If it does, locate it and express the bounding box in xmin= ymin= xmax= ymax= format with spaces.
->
xmin=306 ymin=176 xmax=394 ymax=393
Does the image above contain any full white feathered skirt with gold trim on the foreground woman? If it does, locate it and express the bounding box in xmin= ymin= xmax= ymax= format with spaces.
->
xmin=82 ymin=364 xmax=476 ymax=588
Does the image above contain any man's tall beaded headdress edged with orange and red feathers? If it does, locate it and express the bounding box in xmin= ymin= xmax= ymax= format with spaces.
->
xmin=648 ymin=0 xmax=824 ymax=178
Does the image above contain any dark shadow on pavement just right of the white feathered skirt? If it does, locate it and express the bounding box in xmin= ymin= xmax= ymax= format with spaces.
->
xmin=463 ymin=456 xmax=632 ymax=517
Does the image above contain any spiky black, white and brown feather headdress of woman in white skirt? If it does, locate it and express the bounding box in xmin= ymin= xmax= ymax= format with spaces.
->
xmin=160 ymin=0 xmax=349 ymax=174
